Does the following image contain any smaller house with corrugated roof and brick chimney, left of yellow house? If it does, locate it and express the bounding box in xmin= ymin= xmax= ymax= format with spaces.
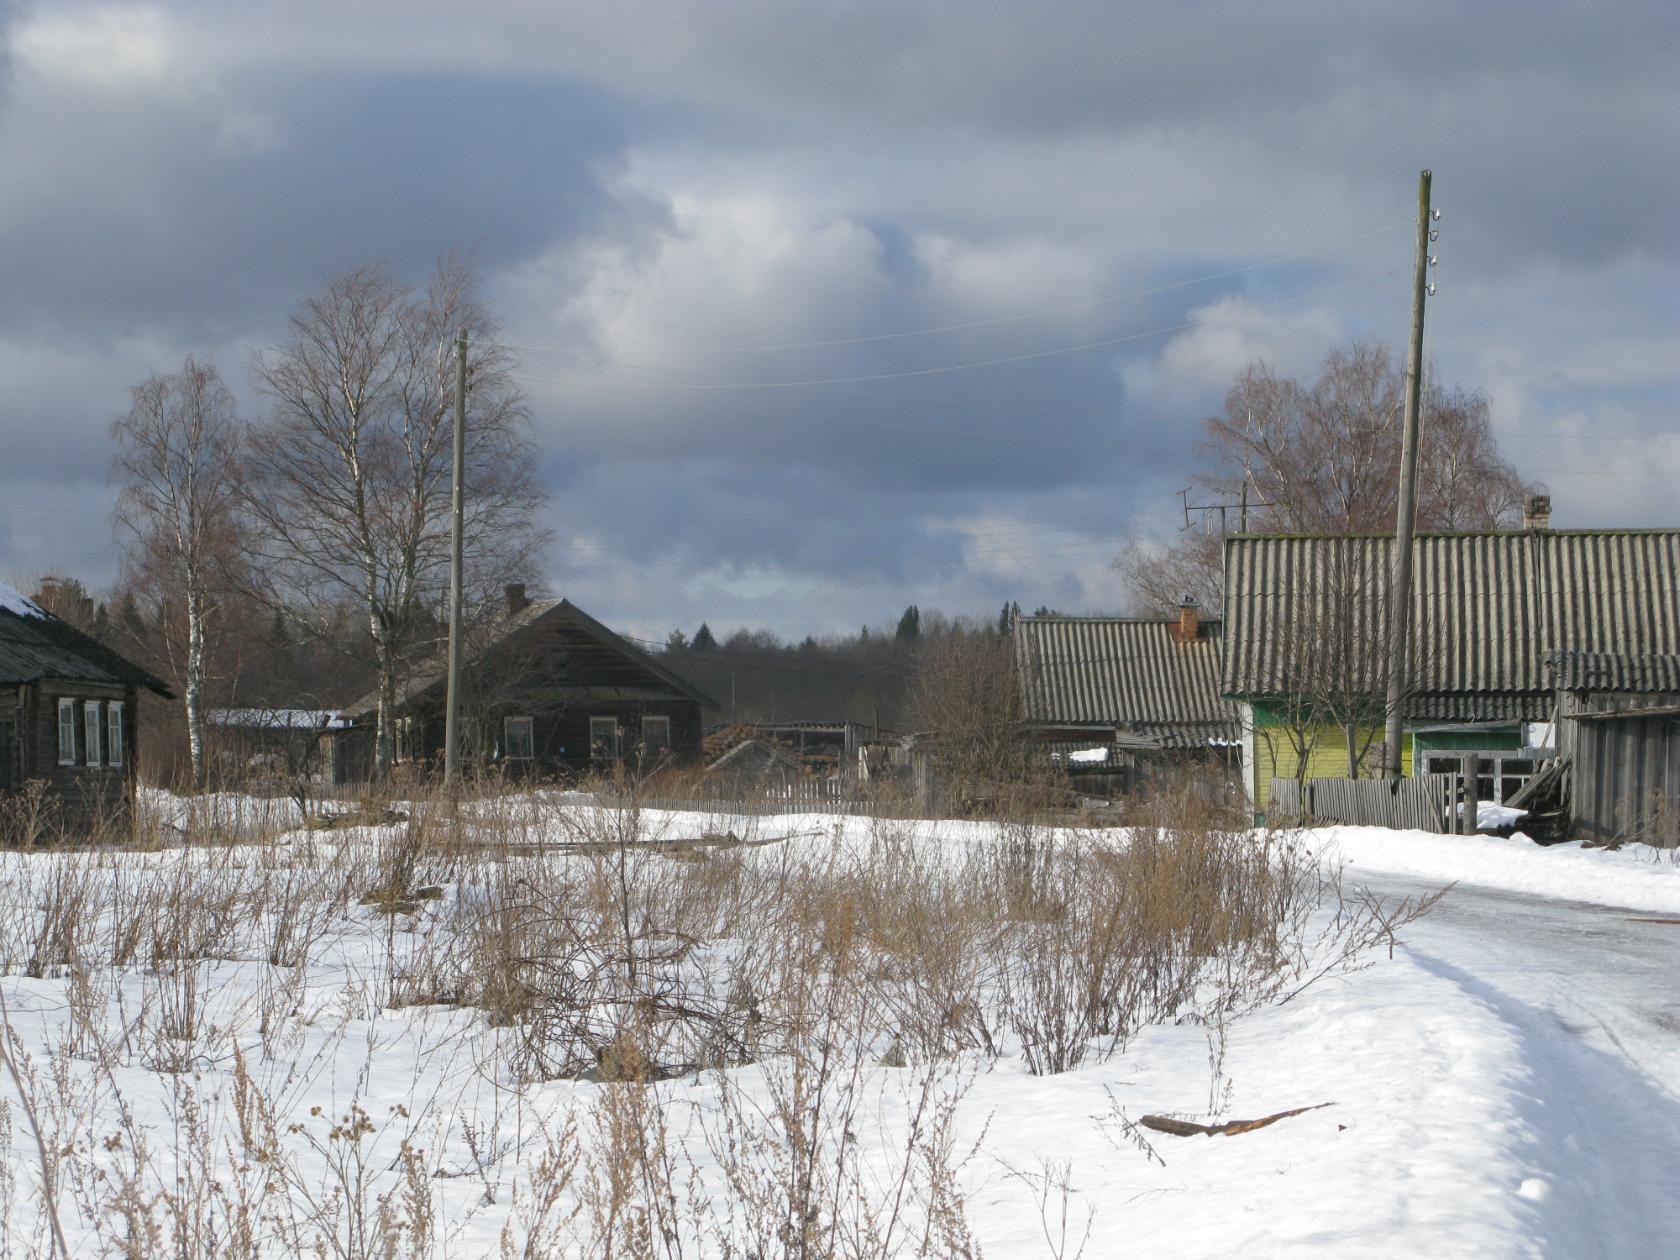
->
xmin=1015 ymin=600 xmax=1242 ymax=790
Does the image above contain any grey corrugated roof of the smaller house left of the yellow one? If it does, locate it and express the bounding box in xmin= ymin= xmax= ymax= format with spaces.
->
xmin=1015 ymin=617 xmax=1240 ymax=748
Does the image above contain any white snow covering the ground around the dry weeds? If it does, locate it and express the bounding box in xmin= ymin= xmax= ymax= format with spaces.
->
xmin=0 ymin=801 xmax=1680 ymax=1258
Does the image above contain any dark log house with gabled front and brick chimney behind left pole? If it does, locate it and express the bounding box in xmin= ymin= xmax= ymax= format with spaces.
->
xmin=333 ymin=585 xmax=716 ymax=783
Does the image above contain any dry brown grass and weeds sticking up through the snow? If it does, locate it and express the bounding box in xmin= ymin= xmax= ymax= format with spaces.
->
xmin=0 ymin=780 xmax=1438 ymax=1260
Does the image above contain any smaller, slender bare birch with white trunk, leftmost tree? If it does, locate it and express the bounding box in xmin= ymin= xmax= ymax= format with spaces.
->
xmin=111 ymin=356 xmax=239 ymax=791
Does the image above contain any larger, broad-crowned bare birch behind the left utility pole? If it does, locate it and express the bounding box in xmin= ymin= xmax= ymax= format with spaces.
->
xmin=245 ymin=259 xmax=543 ymax=774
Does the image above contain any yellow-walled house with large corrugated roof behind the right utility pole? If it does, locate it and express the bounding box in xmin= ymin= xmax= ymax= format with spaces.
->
xmin=1220 ymin=512 xmax=1680 ymax=810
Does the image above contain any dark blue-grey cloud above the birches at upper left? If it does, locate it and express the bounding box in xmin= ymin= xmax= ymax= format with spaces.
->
xmin=0 ymin=74 xmax=648 ymax=339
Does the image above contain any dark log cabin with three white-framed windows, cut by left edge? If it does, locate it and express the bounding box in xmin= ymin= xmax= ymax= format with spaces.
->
xmin=0 ymin=583 xmax=170 ymax=840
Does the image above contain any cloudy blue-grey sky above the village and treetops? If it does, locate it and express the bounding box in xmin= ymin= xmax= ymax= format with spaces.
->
xmin=0 ymin=0 xmax=1680 ymax=635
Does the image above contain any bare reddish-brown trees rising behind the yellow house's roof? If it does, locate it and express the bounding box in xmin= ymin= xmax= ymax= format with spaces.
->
xmin=1116 ymin=341 xmax=1539 ymax=613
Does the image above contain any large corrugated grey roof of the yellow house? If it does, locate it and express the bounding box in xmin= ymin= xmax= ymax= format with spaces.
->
xmin=1220 ymin=529 xmax=1680 ymax=719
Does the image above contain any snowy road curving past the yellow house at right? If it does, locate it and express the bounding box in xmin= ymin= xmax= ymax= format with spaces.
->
xmin=1361 ymin=875 xmax=1680 ymax=1257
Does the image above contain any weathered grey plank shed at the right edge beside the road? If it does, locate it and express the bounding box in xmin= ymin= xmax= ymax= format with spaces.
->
xmin=1551 ymin=652 xmax=1680 ymax=847
